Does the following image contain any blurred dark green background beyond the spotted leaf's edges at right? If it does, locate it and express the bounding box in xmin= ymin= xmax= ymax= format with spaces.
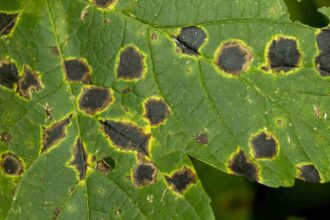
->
xmin=193 ymin=0 xmax=330 ymax=220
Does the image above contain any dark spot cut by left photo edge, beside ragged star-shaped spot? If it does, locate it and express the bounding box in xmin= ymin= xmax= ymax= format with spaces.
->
xmin=0 ymin=60 xmax=19 ymax=89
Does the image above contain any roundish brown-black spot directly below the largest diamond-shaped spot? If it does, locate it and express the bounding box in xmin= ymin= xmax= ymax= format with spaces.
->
xmin=133 ymin=163 xmax=156 ymax=186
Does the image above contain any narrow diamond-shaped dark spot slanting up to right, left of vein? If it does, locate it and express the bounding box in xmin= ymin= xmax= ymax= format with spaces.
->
xmin=41 ymin=115 xmax=72 ymax=152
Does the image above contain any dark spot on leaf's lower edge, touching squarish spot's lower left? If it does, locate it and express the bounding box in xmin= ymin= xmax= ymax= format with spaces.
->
xmin=228 ymin=151 xmax=258 ymax=181
